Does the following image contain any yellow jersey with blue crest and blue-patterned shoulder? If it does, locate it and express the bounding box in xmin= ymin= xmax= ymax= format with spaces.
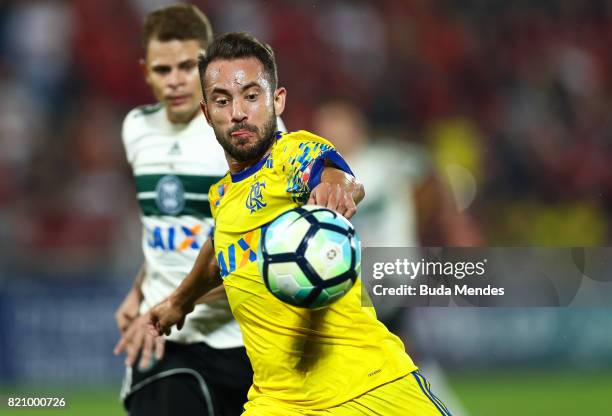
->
xmin=209 ymin=131 xmax=416 ymax=409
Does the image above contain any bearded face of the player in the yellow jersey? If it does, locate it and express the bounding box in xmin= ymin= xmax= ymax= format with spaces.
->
xmin=202 ymin=58 xmax=286 ymax=162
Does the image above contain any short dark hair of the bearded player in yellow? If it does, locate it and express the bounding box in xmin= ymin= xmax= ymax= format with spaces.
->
xmin=198 ymin=32 xmax=278 ymax=99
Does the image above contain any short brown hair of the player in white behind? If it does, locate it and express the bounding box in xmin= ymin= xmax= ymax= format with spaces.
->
xmin=142 ymin=4 xmax=213 ymax=53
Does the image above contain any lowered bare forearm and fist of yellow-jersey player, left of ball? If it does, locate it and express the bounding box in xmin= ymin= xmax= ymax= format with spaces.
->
xmin=148 ymin=239 xmax=221 ymax=335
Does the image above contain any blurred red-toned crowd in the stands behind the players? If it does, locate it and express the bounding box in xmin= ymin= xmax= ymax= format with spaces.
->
xmin=0 ymin=0 xmax=612 ymax=277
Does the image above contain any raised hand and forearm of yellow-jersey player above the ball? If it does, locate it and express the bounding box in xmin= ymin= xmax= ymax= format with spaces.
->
xmin=308 ymin=166 xmax=365 ymax=219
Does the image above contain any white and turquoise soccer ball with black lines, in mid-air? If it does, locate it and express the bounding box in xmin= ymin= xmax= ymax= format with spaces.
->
xmin=257 ymin=205 xmax=361 ymax=309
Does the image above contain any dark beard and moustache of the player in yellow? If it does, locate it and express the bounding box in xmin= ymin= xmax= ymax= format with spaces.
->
xmin=213 ymin=115 xmax=277 ymax=162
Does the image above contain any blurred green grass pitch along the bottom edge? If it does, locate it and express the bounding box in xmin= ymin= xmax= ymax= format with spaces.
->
xmin=0 ymin=370 xmax=612 ymax=416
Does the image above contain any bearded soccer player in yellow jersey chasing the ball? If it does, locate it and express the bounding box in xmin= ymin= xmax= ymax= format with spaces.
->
xmin=149 ymin=33 xmax=450 ymax=416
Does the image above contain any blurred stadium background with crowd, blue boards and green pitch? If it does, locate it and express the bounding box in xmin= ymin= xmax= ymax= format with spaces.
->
xmin=0 ymin=0 xmax=612 ymax=415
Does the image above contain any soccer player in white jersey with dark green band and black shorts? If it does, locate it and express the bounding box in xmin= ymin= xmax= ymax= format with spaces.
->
xmin=115 ymin=4 xmax=283 ymax=416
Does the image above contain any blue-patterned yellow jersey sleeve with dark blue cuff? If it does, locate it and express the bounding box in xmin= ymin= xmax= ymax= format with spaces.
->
xmin=278 ymin=131 xmax=353 ymax=201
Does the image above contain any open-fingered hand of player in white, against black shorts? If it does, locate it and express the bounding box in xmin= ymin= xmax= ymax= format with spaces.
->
xmin=114 ymin=313 xmax=165 ymax=370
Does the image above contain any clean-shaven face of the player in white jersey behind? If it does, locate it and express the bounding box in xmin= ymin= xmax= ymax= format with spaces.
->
xmin=141 ymin=39 xmax=202 ymax=123
